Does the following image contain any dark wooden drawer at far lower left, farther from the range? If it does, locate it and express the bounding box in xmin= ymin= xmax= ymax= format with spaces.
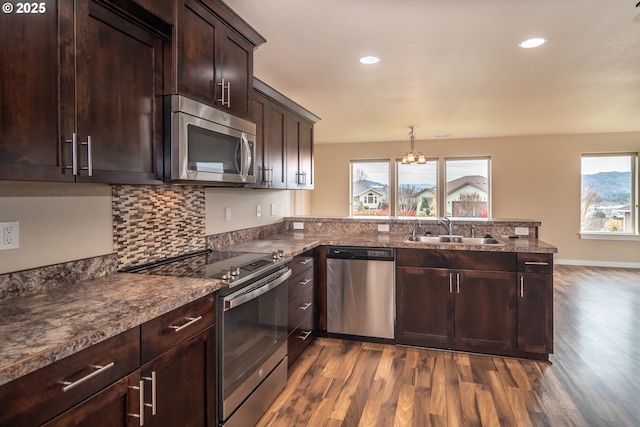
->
xmin=0 ymin=327 xmax=140 ymax=426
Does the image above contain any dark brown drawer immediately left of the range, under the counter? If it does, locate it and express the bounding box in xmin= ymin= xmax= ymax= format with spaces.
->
xmin=140 ymin=294 xmax=215 ymax=363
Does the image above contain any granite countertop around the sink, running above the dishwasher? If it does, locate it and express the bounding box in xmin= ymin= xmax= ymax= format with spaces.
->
xmin=228 ymin=231 xmax=558 ymax=256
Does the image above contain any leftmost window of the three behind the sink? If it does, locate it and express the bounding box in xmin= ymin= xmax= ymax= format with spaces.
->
xmin=351 ymin=160 xmax=390 ymax=216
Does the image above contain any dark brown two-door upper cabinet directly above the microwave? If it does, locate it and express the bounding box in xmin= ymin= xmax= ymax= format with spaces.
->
xmin=171 ymin=0 xmax=265 ymax=119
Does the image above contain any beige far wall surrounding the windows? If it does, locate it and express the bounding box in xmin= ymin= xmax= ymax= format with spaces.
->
xmin=311 ymin=132 xmax=640 ymax=267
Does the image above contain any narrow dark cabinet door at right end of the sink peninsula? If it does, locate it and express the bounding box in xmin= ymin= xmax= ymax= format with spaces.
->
xmin=517 ymin=273 xmax=553 ymax=354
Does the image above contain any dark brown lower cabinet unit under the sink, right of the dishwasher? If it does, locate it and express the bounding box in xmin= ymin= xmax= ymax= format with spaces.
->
xmin=396 ymin=249 xmax=553 ymax=360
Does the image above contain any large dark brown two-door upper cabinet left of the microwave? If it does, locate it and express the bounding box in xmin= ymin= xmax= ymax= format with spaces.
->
xmin=0 ymin=0 xmax=170 ymax=184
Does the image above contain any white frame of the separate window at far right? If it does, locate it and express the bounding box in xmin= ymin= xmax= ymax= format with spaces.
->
xmin=578 ymin=152 xmax=640 ymax=241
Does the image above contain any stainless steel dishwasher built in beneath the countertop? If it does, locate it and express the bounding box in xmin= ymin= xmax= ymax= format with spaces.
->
xmin=327 ymin=246 xmax=396 ymax=339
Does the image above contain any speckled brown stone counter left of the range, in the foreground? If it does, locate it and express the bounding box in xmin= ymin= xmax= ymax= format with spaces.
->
xmin=0 ymin=273 xmax=223 ymax=385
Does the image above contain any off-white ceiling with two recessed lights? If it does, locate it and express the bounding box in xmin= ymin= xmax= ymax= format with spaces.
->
xmin=225 ymin=0 xmax=640 ymax=143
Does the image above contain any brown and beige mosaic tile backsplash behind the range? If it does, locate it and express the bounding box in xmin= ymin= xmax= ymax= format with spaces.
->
xmin=112 ymin=185 xmax=207 ymax=269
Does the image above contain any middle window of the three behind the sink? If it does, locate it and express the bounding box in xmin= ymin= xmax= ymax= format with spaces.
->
xmin=396 ymin=159 xmax=438 ymax=217
